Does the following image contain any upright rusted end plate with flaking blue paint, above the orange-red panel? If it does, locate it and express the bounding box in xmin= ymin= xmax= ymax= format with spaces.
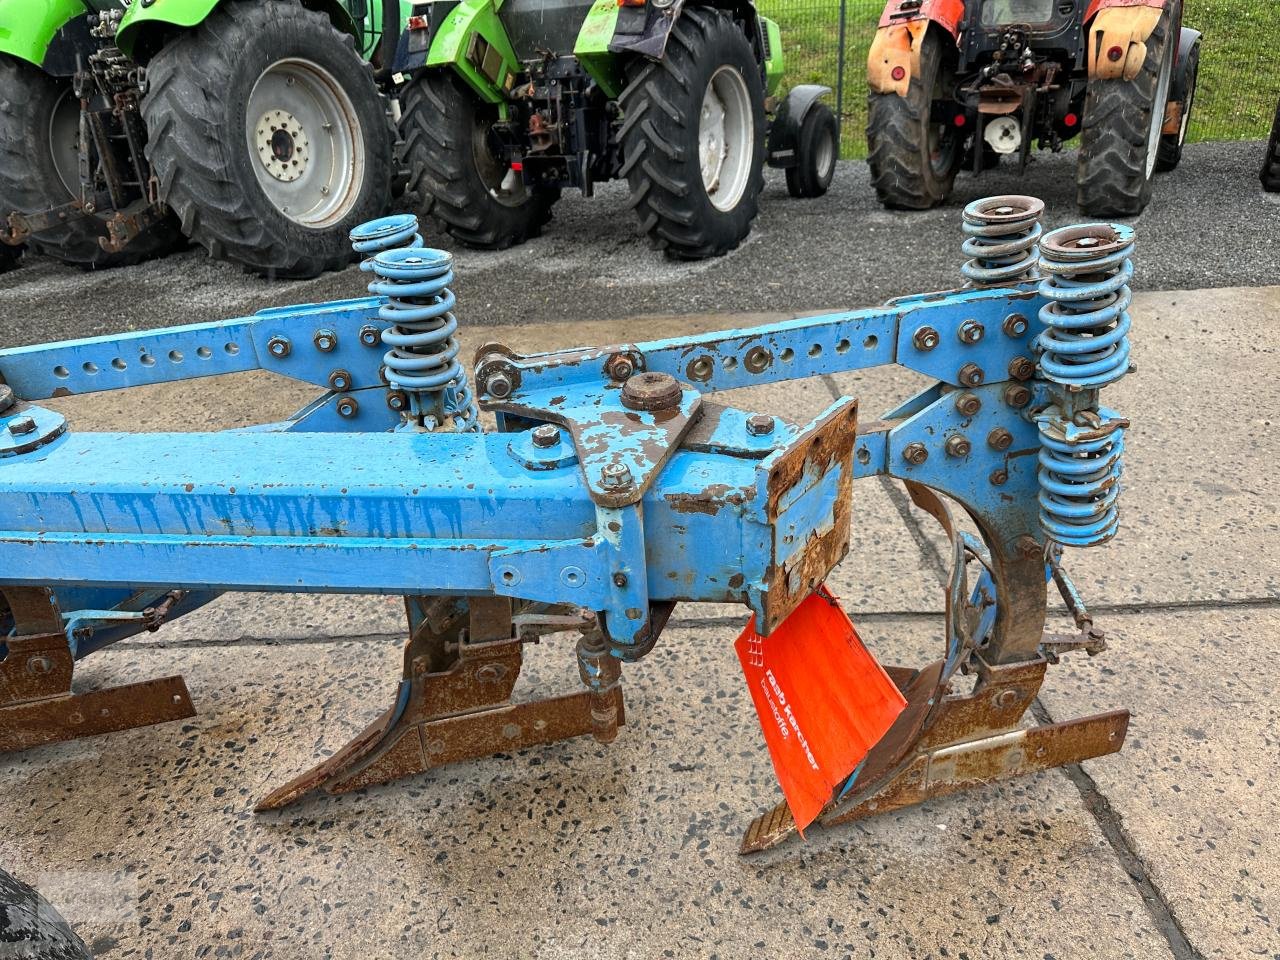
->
xmin=760 ymin=402 xmax=858 ymax=635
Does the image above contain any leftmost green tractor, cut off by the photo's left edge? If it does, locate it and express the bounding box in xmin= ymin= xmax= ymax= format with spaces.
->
xmin=0 ymin=0 xmax=407 ymax=276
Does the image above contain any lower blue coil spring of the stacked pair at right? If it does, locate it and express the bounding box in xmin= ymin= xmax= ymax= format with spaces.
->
xmin=1037 ymin=407 xmax=1128 ymax=547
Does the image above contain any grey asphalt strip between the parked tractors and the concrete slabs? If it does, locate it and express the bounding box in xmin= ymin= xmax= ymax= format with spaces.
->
xmin=0 ymin=136 xmax=1280 ymax=346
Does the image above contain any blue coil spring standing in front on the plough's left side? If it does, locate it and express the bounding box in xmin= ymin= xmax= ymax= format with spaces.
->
xmin=369 ymin=247 xmax=479 ymax=433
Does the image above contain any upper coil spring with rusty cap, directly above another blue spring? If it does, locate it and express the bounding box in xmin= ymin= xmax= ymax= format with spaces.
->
xmin=1037 ymin=224 xmax=1133 ymax=389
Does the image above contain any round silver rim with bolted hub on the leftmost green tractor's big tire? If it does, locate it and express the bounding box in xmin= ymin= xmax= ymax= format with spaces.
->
xmin=244 ymin=58 xmax=365 ymax=228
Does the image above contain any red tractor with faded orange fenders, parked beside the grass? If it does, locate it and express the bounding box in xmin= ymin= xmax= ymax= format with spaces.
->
xmin=867 ymin=0 xmax=1199 ymax=216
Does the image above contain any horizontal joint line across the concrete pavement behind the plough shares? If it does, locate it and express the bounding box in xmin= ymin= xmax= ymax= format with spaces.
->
xmin=108 ymin=596 xmax=1280 ymax=650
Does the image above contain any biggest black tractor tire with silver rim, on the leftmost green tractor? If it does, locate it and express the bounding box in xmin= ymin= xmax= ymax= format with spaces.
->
xmin=142 ymin=0 xmax=394 ymax=278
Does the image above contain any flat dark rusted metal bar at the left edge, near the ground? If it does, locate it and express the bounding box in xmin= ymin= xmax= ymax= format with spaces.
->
xmin=0 ymin=677 xmax=196 ymax=753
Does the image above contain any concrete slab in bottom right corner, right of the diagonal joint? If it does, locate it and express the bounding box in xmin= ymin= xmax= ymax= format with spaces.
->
xmin=1041 ymin=607 xmax=1280 ymax=960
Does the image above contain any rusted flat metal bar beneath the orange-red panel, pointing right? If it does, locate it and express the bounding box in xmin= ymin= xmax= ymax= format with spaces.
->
xmin=822 ymin=710 xmax=1129 ymax=827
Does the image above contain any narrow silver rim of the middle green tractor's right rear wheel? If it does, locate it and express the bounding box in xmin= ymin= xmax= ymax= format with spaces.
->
xmin=698 ymin=65 xmax=755 ymax=212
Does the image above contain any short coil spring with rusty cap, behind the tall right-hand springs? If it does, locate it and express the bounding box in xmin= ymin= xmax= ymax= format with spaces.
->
xmin=960 ymin=195 xmax=1044 ymax=287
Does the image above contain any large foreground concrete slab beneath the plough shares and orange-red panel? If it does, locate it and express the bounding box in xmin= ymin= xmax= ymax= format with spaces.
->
xmin=0 ymin=621 xmax=1170 ymax=960
